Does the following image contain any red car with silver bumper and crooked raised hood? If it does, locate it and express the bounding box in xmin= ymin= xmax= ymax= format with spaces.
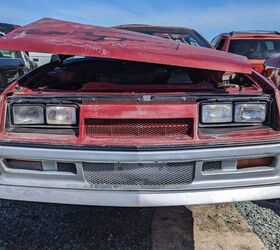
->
xmin=0 ymin=19 xmax=280 ymax=206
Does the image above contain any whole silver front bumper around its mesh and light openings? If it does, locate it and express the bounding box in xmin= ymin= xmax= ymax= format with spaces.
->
xmin=0 ymin=144 xmax=280 ymax=206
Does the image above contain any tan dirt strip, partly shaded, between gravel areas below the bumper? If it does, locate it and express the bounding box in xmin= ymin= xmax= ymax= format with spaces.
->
xmin=152 ymin=204 xmax=266 ymax=250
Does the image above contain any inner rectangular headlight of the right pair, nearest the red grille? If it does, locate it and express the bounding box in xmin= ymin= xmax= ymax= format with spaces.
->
xmin=201 ymin=103 xmax=233 ymax=123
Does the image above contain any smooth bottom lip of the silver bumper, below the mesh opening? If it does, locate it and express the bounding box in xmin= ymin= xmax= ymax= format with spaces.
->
xmin=0 ymin=184 xmax=280 ymax=207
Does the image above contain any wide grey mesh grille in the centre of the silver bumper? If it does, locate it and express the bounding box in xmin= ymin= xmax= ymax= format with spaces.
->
xmin=83 ymin=162 xmax=195 ymax=189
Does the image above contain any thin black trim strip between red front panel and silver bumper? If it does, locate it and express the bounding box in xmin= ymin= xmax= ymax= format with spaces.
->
xmin=0 ymin=140 xmax=280 ymax=152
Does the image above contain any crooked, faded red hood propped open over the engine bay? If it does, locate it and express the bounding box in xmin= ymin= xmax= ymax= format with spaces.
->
xmin=0 ymin=18 xmax=252 ymax=73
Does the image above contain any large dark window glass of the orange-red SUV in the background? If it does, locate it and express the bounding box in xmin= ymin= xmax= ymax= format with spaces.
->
xmin=229 ymin=39 xmax=280 ymax=59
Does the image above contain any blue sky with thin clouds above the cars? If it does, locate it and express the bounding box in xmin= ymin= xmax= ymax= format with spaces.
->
xmin=0 ymin=0 xmax=280 ymax=39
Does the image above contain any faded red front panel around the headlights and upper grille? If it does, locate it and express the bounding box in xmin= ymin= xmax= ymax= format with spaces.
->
xmin=0 ymin=75 xmax=280 ymax=146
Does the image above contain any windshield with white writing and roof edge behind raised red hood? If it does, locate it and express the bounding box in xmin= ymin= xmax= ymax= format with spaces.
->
xmin=113 ymin=24 xmax=212 ymax=48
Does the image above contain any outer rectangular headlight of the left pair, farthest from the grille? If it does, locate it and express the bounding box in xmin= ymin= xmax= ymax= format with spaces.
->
xmin=12 ymin=105 xmax=44 ymax=125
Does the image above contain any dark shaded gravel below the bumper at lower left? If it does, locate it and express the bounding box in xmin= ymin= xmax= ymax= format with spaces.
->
xmin=0 ymin=200 xmax=154 ymax=249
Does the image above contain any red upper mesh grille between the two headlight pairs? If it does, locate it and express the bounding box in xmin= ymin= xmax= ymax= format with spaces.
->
xmin=85 ymin=119 xmax=191 ymax=137
